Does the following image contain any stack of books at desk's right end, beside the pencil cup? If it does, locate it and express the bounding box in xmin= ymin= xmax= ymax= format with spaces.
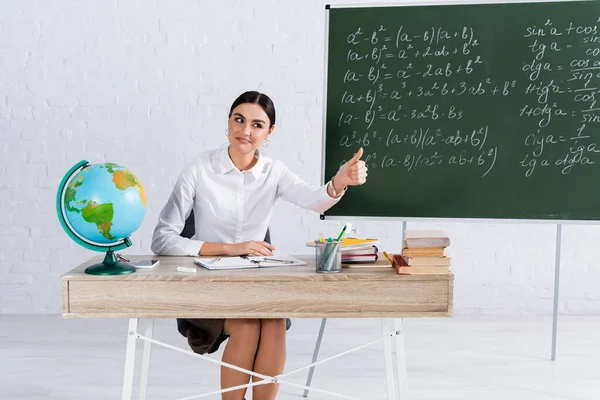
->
xmin=393 ymin=230 xmax=451 ymax=275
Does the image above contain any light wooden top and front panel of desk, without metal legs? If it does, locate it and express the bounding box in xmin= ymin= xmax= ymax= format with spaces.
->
xmin=62 ymin=256 xmax=454 ymax=318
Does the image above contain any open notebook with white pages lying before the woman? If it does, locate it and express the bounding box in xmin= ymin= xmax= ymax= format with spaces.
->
xmin=194 ymin=255 xmax=306 ymax=270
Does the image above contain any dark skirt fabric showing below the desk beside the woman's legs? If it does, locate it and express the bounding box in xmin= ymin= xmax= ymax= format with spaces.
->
xmin=177 ymin=318 xmax=292 ymax=354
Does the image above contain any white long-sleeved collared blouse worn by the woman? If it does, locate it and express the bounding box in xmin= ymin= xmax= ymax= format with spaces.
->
xmin=152 ymin=147 xmax=342 ymax=256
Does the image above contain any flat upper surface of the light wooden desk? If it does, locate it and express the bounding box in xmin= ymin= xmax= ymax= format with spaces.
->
xmin=62 ymin=255 xmax=454 ymax=282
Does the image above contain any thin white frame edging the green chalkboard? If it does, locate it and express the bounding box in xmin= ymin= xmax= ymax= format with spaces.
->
xmin=320 ymin=0 xmax=600 ymax=225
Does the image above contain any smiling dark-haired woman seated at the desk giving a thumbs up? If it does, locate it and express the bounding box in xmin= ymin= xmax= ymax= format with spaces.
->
xmin=152 ymin=92 xmax=367 ymax=400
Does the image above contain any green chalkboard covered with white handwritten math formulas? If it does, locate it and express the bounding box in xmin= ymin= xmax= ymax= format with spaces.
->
xmin=323 ymin=1 xmax=600 ymax=221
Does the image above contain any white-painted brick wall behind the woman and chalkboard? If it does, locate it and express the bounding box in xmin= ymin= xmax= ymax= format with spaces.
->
xmin=0 ymin=0 xmax=600 ymax=314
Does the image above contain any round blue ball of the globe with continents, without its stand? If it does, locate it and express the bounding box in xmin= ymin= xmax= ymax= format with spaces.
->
xmin=64 ymin=163 xmax=146 ymax=244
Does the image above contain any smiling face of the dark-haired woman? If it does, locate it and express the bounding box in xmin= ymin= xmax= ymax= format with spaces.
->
xmin=227 ymin=103 xmax=275 ymax=154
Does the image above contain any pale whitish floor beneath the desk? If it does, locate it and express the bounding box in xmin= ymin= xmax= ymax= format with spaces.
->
xmin=0 ymin=315 xmax=600 ymax=400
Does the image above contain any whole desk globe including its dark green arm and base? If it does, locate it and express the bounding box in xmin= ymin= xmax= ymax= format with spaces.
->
xmin=56 ymin=160 xmax=146 ymax=275
